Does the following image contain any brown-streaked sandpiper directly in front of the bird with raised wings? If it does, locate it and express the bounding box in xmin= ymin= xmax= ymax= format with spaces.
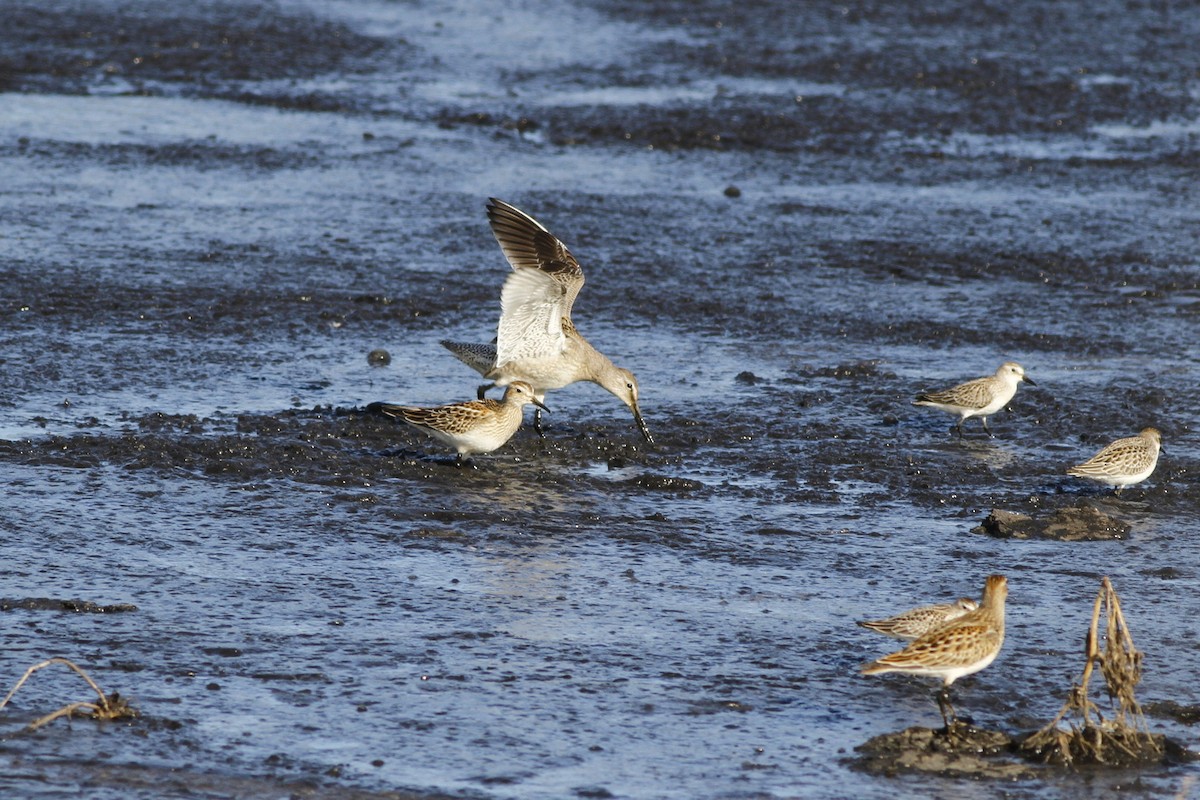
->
xmin=366 ymin=380 xmax=550 ymax=464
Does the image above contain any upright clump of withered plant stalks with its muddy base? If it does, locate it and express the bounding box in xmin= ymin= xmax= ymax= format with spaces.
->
xmin=1021 ymin=578 xmax=1164 ymax=766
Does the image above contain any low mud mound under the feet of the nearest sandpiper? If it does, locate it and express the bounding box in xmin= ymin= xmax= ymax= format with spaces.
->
xmin=850 ymin=724 xmax=1037 ymax=781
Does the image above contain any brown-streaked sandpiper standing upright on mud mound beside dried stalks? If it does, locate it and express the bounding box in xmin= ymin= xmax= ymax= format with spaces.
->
xmin=863 ymin=575 xmax=1008 ymax=730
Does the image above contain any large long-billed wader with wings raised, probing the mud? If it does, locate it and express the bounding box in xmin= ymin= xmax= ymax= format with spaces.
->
xmin=442 ymin=198 xmax=654 ymax=441
